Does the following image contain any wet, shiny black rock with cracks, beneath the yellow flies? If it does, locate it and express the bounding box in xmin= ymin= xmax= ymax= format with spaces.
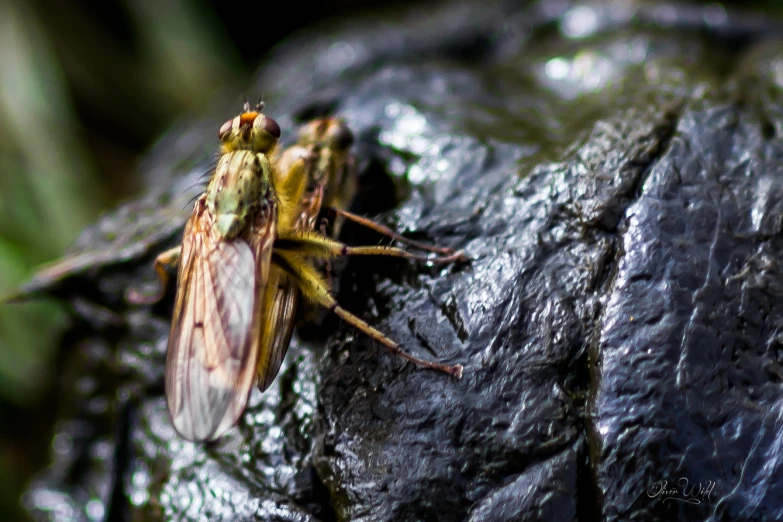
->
xmin=18 ymin=2 xmax=783 ymax=522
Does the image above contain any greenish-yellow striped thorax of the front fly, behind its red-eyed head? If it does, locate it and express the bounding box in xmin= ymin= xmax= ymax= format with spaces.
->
xmin=207 ymin=151 xmax=269 ymax=239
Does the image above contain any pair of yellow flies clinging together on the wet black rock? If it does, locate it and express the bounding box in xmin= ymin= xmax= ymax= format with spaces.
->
xmin=137 ymin=104 xmax=462 ymax=441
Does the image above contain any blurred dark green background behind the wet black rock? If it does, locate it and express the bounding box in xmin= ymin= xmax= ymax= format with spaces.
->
xmin=0 ymin=0 xmax=783 ymax=521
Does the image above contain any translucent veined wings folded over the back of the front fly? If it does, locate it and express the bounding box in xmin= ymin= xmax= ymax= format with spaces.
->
xmin=166 ymin=200 xmax=275 ymax=441
